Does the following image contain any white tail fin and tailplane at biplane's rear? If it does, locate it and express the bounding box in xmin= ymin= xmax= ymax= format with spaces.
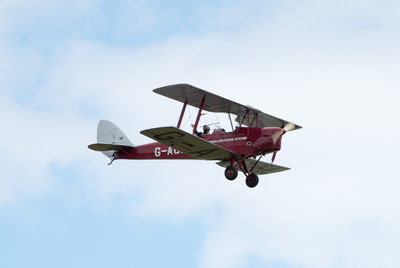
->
xmin=88 ymin=120 xmax=134 ymax=158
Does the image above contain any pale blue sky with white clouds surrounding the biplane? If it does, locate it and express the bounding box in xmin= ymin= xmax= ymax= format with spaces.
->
xmin=0 ymin=0 xmax=400 ymax=268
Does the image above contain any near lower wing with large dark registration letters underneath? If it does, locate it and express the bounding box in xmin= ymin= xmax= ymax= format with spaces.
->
xmin=140 ymin=127 xmax=239 ymax=160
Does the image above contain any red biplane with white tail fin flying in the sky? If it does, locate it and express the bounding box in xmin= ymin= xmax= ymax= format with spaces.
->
xmin=88 ymin=84 xmax=301 ymax=188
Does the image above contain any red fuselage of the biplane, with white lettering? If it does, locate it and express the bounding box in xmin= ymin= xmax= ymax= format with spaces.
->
xmin=115 ymin=127 xmax=281 ymax=160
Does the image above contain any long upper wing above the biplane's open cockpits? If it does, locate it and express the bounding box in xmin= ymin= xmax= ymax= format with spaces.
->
xmin=153 ymin=84 xmax=301 ymax=129
